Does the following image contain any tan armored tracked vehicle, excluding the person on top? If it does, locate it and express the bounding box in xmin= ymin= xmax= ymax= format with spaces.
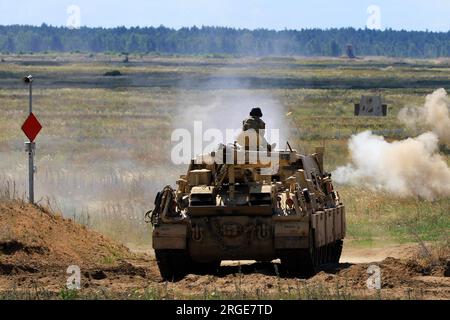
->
xmin=149 ymin=139 xmax=346 ymax=280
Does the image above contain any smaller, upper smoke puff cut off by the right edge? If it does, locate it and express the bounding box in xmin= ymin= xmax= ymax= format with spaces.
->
xmin=398 ymin=89 xmax=450 ymax=144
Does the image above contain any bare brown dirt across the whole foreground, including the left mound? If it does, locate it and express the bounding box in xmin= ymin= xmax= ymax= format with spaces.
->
xmin=0 ymin=202 xmax=450 ymax=299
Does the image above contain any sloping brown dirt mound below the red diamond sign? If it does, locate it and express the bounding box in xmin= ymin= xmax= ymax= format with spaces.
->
xmin=0 ymin=202 xmax=131 ymax=274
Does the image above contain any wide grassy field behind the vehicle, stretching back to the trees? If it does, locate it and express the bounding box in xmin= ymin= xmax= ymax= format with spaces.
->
xmin=0 ymin=54 xmax=450 ymax=246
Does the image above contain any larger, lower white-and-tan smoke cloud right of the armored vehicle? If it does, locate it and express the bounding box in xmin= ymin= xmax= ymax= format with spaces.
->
xmin=333 ymin=131 xmax=450 ymax=200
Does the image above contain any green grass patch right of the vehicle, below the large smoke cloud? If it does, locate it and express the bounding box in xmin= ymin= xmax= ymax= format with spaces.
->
xmin=340 ymin=187 xmax=450 ymax=246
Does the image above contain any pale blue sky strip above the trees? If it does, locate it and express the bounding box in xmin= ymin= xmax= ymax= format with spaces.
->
xmin=0 ymin=0 xmax=450 ymax=31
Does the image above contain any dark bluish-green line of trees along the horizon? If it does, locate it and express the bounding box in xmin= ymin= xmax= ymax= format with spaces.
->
xmin=0 ymin=24 xmax=450 ymax=58
